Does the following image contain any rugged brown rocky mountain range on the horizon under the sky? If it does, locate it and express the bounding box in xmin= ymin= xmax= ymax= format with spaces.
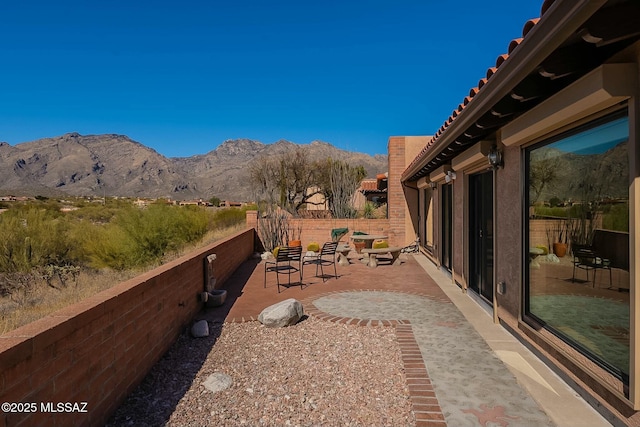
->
xmin=0 ymin=133 xmax=387 ymax=201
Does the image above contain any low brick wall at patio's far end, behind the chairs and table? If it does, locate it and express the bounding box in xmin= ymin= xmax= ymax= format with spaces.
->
xmin=247 ymin=211 xmax=395 ymax=247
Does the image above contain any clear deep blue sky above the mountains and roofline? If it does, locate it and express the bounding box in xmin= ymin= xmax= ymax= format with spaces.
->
xmin=0 ymin=0 xmax=542 ymax=157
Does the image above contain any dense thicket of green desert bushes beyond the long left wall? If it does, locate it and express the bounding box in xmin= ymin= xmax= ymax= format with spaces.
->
xmin=0 ymin=200 xmax=218 ymax=273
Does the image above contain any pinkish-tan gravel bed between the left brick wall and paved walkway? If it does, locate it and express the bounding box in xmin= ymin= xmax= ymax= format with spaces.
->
xmin=108 ymin=317 xmax=415 ymax=426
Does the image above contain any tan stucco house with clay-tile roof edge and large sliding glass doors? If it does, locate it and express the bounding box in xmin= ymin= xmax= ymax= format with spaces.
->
xmin=388 ymin=0 xmax=640 ymax=425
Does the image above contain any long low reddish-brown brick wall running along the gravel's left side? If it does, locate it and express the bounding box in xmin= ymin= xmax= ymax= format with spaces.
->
xmin=0 ymin=229 xmax=255 ymax=426
